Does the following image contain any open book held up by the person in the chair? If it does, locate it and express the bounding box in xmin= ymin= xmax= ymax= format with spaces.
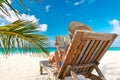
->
xmin=56 ymin=36 xmax=70 ymax=48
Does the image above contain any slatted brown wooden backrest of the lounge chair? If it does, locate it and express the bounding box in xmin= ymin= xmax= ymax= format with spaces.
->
xmin=58 ymin=30 xmax=117 ymax=78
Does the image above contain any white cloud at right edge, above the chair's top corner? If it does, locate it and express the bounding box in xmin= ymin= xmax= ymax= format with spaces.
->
xmin=109 ymin=19 xmax=120 ymax=34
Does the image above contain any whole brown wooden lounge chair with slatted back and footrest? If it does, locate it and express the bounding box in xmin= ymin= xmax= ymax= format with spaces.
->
xmin=40 ymin=30 xmax=117 ymax=80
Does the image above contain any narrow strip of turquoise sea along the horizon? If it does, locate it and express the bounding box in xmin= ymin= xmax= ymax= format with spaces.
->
xmin=0 ymin=47 xmax=120 ymax=54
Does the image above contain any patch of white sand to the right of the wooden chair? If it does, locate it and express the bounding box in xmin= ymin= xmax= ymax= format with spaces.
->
xmin=99 ymin=51 xmax=120 ymax=80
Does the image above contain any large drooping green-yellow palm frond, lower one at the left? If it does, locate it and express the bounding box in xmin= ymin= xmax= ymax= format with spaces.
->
xmin=0 ymin=20 xmax=48 ymax=55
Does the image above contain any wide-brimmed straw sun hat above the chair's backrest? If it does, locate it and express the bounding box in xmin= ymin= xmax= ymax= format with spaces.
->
xmin=68 ymin=22 xmax=92 ymax=39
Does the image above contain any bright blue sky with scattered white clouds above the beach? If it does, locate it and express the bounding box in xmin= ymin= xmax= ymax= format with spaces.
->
xmin=0 ymin=0 xmax=120 ymax=47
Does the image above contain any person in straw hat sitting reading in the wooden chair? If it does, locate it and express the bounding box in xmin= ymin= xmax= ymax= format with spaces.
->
xmin=49 ymin=22 xmax=92 ymax=70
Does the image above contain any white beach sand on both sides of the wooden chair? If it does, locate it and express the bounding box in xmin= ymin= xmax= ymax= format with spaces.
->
xmin=0 ymin=51 xmax=120 ymax=80
